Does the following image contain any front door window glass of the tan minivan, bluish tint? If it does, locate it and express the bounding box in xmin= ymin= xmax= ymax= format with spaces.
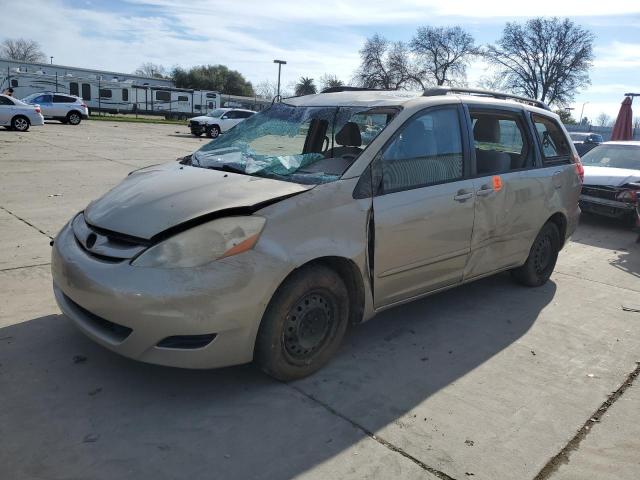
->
xmin=382 ymin=108 xmax=464 ymax=193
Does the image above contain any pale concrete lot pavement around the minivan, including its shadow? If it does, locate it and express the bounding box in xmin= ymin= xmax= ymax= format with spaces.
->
xmin=0 ymin=122 xmax=640 ymax=480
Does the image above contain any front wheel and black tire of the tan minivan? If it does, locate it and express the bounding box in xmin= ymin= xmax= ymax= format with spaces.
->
xmin=255 ymin=265 xmax=349 ymax=381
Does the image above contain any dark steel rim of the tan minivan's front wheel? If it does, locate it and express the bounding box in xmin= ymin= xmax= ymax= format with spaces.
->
xmin=283 ymin=292 xmax=336 ymax=360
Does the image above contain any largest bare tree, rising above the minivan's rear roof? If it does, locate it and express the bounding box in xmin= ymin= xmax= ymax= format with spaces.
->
xmin=484 ymin=18 xmax=594 ymax=105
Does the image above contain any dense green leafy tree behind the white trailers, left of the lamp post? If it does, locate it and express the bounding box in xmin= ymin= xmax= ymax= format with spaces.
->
xmin=171 ymin=65 xmax=254 ymax=97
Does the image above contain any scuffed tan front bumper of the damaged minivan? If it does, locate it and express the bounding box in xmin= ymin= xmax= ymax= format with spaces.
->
xmin=51 ymin=220 xmax=286 ymax=368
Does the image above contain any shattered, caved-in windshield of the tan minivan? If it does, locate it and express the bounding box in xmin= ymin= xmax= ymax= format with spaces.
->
xmin=191 ymin=103 xmax=396 ymax=184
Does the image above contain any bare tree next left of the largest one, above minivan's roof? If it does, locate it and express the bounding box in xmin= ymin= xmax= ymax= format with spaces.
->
xmin=410 ymin=27 xmax=478 ymax=86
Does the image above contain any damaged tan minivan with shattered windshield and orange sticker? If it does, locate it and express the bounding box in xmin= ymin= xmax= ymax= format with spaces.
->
xmin=51 ymin=88 xmax=582 ymax=380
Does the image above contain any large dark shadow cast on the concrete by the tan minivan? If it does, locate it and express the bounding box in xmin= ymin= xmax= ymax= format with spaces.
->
xmin=0 ymin=275 xmax=556 ymax=479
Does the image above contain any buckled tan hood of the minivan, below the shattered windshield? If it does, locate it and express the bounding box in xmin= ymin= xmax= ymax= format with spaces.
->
xmin=84 ymin=162 xmax=313 ymax=239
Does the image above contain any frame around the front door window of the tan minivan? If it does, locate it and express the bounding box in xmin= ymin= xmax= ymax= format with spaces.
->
xmin=372 ymin=102 xmax=471 ymax=197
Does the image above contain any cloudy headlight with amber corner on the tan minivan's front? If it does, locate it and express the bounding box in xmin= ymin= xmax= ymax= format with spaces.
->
xmin=131 ymin=216 xmax=265 ymax=268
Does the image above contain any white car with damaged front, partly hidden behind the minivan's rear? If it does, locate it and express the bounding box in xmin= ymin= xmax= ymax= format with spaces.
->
xmin=580 ymin=142 xmax=640 ymax=223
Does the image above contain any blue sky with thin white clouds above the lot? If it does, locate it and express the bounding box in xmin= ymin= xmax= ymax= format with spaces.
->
xmin=0 ymin=0 xmax=640 ymax=119
